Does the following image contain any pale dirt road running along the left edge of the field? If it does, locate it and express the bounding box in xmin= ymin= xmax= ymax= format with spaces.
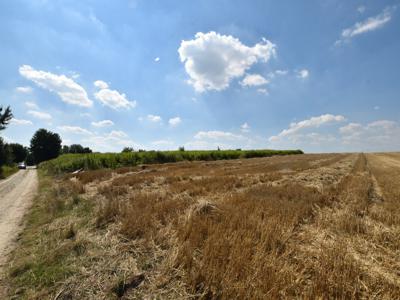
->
xmin=0 ymin=169 xmax=38 ymax=271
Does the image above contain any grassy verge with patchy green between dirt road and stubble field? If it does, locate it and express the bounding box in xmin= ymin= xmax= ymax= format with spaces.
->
xmin=6 ymin=170 xmax=92 ymax=299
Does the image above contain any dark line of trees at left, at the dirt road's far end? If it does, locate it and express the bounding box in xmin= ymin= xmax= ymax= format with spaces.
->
xmin=0 ymin=106 xmax=92 ymax=176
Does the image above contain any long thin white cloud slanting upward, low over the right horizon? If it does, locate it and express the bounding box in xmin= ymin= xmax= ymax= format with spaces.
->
xmin=269 ymin=114 xmax=345 ymax=142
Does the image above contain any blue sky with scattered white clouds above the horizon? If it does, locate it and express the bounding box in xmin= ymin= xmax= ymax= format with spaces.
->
xmin=0 ymin=0 xmax=400 ymax=152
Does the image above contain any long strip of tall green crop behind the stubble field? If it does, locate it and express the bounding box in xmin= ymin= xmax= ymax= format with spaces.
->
xmin=39 ymin=150 xmax=303 ymax=174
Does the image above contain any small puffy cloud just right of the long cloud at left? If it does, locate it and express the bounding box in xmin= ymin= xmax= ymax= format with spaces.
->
xmin=94 ymin=80 xmax=137 ymax=110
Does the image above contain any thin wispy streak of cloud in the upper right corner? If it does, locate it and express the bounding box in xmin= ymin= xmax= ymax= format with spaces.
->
xmin=335 ymin=7 xmax=396 ymax=45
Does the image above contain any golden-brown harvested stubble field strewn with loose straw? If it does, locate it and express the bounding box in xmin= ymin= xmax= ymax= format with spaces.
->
xmin=9 ymin=153 xmax=400 ymax=299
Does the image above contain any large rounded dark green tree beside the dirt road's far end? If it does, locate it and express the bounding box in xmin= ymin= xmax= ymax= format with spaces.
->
xmin=30 ymin=128 xmax=61 ymax=164
